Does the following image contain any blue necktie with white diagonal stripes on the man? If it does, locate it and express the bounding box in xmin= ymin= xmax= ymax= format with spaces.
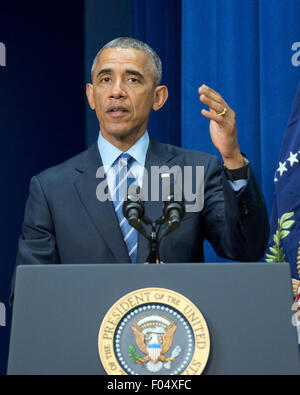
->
xmin=112 ymin=153 xmax=138 ymax=263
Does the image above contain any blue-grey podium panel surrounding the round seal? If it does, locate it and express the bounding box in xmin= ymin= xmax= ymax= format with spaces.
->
xmin=7 ymin=263 xmax=300 ymax=375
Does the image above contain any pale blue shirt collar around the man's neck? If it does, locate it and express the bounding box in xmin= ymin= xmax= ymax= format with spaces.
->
xmin=98 ymin=130 xmax=149 ymax=170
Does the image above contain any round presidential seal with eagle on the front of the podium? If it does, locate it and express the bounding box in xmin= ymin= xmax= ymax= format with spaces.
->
xmin=98 ymin=288 xmax=210 ymax=375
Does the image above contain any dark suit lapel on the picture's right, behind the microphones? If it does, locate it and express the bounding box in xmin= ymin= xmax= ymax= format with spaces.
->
xmin=137 ymin=138 xmax=174 ymax=263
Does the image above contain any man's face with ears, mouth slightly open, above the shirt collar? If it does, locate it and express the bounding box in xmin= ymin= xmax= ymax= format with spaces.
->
xmin=87 ymin=48 xmax=167 ymax=142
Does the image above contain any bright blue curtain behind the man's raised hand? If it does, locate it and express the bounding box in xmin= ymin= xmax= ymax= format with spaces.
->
xmin=181 ymin=0 xmax=300 ymax=261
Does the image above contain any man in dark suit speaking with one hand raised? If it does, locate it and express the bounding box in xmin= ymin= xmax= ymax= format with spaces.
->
xmin=13 ymin=38 xmax=269 ymax=272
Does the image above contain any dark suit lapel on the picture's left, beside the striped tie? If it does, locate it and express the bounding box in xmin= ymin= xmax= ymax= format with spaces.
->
xmin=75 ymin=144 xmax=130 ymax=263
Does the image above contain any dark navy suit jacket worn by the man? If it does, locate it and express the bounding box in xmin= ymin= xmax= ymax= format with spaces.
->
xmin=17 ymin=139 xmax=269 ymax=265
